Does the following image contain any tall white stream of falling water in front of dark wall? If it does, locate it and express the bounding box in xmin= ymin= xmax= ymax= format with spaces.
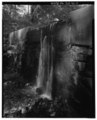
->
xmin=36 ymin=33 xmax=53 ymax=99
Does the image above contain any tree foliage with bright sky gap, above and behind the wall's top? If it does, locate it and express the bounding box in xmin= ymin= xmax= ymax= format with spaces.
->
xmin=2 ymin=4 xmax=78 ymax=72
